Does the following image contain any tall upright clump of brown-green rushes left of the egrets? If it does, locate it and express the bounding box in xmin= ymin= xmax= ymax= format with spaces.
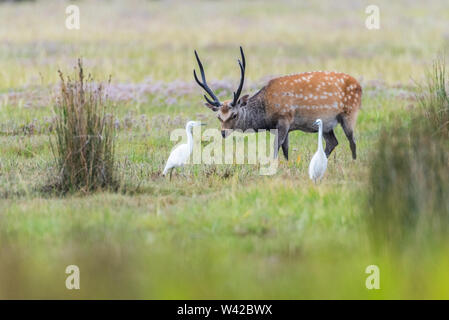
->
xmin=50 ymin=60 xmax=118 ymax=193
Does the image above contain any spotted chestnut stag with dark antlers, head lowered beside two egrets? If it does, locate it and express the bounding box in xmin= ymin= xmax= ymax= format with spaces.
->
xmin=193 ymin=47 xmax=362 ymax=159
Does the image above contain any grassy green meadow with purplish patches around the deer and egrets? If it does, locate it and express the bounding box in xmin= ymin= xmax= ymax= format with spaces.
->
xmin=0 ymin=0 xmax=449 ymax=299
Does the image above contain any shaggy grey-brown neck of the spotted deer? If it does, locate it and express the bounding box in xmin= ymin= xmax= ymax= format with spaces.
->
xmin=236 ymin=88 xmax=266 ymax=131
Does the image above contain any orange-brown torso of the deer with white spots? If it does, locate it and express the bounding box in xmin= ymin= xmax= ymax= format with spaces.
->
xmin=264 ymin=71 xmax=362 ymax=131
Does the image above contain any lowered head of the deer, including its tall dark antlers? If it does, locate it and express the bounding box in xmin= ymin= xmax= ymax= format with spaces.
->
xmin=193 ymin=47 xmax=249 ymax=138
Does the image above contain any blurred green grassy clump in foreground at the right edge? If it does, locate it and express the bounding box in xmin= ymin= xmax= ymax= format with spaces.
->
xmin=368 ymin=60 xmax=449 ymax=247
